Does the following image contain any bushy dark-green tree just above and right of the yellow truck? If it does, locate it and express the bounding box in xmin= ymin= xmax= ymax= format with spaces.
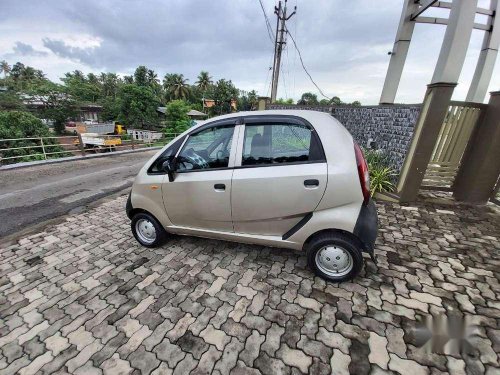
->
xmin=119 ymin=84 xmax=160 ymax=128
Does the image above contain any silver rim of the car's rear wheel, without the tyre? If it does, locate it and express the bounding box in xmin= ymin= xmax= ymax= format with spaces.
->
xmin=316 ymin=245 xmax=354 ymax=277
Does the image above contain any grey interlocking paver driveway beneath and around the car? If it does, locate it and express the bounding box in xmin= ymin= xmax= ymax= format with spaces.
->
xmin=0 ymin=197 xmax=500 ymax=375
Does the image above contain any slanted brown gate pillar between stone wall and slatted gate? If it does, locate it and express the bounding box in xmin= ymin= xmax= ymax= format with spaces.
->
xmin=398 ymin=82 xmax=457 ymax=202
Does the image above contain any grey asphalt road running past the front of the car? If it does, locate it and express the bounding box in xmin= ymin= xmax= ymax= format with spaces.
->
xmin=0 ymin=150 xmax=157 ymax=238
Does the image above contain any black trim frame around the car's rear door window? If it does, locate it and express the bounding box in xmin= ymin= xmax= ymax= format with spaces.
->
xmin=239 ymin=115 xmax=326 ymax=169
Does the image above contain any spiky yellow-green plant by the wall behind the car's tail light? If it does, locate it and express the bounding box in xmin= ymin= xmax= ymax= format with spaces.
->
xmin=364 ymin=150 xmax=396 ymax=196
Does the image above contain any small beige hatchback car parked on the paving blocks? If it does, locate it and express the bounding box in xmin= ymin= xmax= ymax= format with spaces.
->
xmin=126 ymin=110 xmax=378 ymax=281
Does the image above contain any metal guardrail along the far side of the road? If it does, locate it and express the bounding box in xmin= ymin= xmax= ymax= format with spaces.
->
xmin=0 ymin=133 xmax=178 ymax=165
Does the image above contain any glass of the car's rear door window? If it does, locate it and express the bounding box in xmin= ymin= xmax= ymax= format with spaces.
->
xmin=241 ymin=123 xmax=322 ymax=166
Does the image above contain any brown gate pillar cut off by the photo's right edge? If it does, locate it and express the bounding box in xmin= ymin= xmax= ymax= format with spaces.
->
xmin=453 ymin=91 xmax=500 ymax=204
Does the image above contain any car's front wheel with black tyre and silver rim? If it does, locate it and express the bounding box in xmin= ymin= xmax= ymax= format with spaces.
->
xmin=130 ymin=212 xmax=167 ymax=248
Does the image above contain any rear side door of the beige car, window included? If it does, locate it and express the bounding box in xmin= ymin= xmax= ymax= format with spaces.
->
xmin=232 ymin=116 xmax=327 ymax=236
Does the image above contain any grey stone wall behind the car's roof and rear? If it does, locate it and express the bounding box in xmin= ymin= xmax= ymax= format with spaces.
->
xmin=266 ymin=104 xmax=421 ymax=173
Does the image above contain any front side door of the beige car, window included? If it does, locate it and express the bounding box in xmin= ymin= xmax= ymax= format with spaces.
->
xmin=162 ymin=120 xmax=237 ymax=232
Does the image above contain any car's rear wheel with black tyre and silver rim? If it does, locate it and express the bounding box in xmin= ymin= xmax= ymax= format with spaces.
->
xmin=306 ymin=232 xmax=363 ymax=282
